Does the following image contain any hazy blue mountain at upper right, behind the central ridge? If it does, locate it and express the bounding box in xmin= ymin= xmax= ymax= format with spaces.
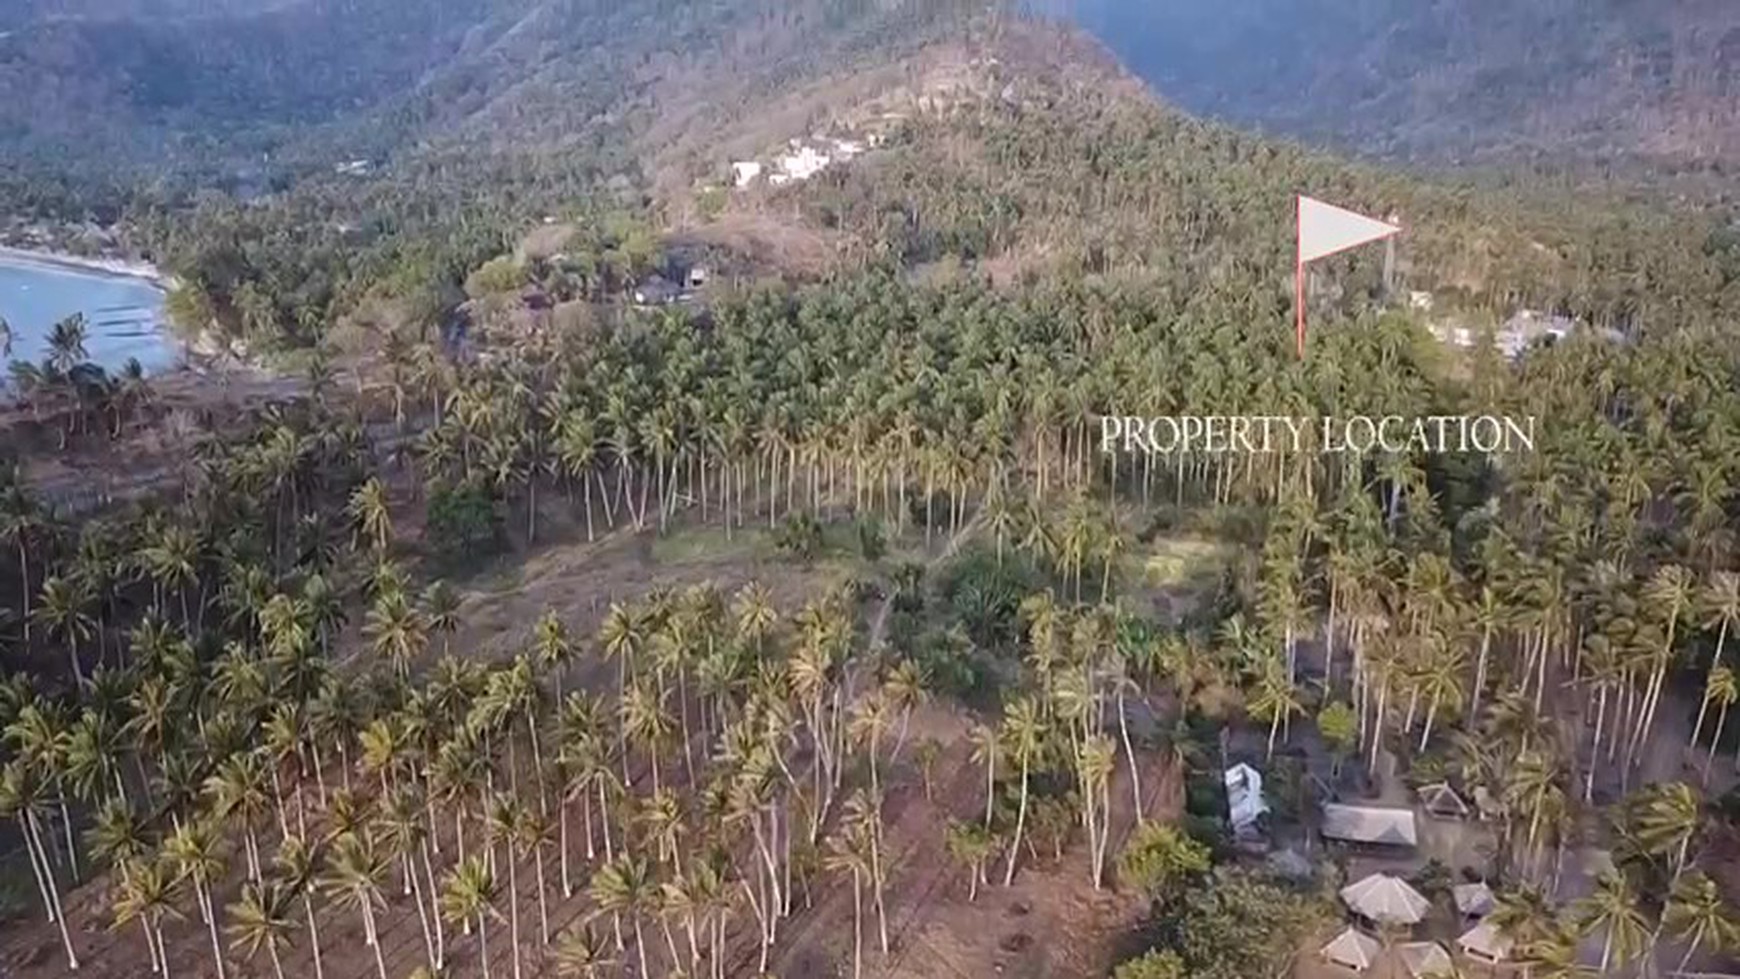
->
xmin=1053 ymin=0 xmax=1740 ymax=160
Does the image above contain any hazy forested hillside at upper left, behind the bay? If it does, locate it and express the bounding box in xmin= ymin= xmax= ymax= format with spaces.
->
xmin=0 ymin=0 xmax=981 ymax=195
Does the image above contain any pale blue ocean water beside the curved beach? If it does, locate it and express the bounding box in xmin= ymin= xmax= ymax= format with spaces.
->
xmin=0 ymin=257 xmax=181 ymax=372
